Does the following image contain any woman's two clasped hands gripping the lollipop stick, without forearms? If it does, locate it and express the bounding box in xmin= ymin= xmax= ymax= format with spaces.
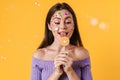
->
xmin=54 ymin=52 xmax=73 ymax=74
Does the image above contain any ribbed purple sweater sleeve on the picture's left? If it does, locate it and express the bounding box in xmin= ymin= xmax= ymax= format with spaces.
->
xmin=31 ymin=58 xmax=42 ymax=80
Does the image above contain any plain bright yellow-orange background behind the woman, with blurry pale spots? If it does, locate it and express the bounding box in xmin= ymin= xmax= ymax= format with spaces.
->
xmin=0 ymin=0 xmax=120 ymax=80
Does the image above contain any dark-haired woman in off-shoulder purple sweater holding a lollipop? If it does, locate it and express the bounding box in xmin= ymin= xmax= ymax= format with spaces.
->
xmin=31 ymin=3 xmax=92 ymax=80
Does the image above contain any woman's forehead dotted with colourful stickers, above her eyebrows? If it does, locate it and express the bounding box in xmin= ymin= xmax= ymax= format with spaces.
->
xmin=52 ymin=9 xmax=72 ymax=18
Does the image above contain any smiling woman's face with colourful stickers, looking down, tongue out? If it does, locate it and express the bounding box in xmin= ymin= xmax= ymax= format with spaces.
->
xmin=48 ymin=9 xmax=74 ymax=39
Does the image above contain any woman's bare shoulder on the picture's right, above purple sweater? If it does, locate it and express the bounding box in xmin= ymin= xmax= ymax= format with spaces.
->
xmin=75 ymin=47 xmax=89 ymax=60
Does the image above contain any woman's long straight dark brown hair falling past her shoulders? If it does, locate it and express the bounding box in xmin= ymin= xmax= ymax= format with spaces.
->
xmin=38 ymin=3 xmax=83 ymax=49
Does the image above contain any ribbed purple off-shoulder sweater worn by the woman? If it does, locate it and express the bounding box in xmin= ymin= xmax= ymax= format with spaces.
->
xmin=31 ymin=57 xmax=92 ymax=80
